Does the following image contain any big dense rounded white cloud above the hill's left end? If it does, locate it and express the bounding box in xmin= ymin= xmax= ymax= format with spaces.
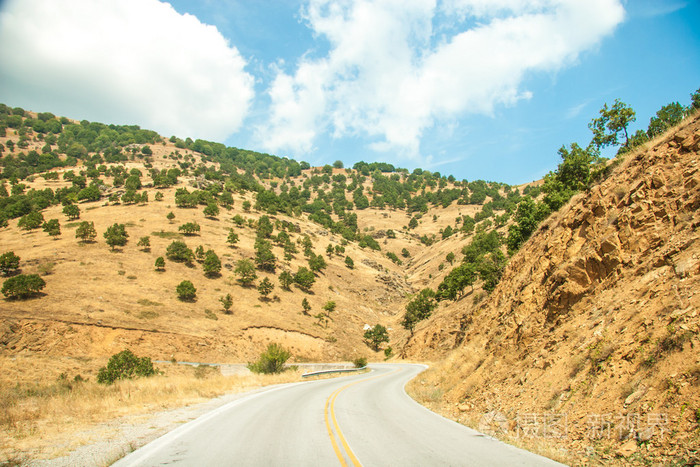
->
xmin=0 ymin=0 xmax=254 ymax=140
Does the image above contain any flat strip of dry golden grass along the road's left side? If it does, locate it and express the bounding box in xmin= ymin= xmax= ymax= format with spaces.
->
xmin=0 ymin=357 xmax=301 ymax=459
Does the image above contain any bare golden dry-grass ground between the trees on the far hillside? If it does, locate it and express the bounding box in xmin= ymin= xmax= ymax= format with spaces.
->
xmin=0 ymin=112 xmax=506 ymax=370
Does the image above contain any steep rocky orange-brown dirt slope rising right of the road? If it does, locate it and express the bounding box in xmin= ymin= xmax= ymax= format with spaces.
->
xmin=405 ymin=117 xmax=700 ymax=462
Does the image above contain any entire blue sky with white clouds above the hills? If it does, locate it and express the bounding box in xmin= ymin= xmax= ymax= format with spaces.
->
xmin=0 ymin=0 xmax=700 ymax=184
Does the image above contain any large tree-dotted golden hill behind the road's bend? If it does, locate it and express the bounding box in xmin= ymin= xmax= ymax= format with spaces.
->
xmin=0 ymin=107 xmax=520 ymax=363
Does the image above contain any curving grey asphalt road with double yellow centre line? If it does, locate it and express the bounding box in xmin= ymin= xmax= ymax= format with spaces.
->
xmin=114 ymin=364 xmax=560 ymax=467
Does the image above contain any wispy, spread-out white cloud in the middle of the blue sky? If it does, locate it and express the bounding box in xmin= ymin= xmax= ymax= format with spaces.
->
xmin=258 ymin=0 xmax=624 ymax=156
